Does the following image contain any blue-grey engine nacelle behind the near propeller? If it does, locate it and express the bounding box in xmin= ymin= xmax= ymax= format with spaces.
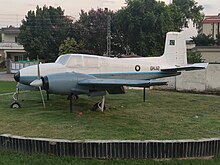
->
xmin=42 ymin=72 xmax=95 ymax=95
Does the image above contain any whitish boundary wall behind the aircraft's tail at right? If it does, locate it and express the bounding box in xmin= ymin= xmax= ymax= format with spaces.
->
xmin=154 ymin=64 xmax=220 ymax=92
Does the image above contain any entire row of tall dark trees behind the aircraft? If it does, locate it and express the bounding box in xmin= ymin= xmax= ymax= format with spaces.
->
xmin=18 ymin=0 xmax=203 ymax=61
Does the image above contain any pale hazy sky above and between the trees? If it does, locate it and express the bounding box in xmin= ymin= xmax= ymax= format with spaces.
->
xmin=0 ymin=0 xmax=220 ymax=38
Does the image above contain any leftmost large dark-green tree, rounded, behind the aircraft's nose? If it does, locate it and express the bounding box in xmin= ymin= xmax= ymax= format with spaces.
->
xmin=18 ymin=6 xmax=72 ymax=61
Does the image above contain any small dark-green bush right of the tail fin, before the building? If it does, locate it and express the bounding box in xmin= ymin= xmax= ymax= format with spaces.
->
xmin=192 ymin=33 xmax=215 ymax=46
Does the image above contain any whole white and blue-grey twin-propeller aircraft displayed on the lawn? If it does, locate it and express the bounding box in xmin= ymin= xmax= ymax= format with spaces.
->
xmin=11 ymin=32 xmax=208 ymax=111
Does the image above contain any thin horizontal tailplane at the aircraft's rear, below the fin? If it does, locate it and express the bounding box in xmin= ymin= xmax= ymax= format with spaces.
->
xmin=161 ymin=63 xmax=208 ymax=72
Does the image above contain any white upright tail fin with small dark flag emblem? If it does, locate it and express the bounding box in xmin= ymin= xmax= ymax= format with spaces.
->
xmin=162 ymin=32 xmax=187 ymax=66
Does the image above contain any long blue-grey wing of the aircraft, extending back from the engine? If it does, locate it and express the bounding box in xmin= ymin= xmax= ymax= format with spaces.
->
xmin=78 ymin=79 xmax=167 ymax=87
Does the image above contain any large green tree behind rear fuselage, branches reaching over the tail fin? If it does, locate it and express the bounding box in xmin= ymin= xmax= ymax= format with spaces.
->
xmin=113 ymin=0 xmax=202 ymax=56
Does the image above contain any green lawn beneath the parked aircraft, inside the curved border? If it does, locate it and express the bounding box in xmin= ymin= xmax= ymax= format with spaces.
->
xmin=0 ymin=82 xmax=220 ymax=140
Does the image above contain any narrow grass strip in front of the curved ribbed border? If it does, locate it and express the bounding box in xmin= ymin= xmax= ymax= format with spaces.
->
xmin=0 ymin=152 xmax=220 ymax=165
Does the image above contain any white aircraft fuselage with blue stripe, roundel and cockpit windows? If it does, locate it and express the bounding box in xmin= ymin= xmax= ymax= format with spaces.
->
xmin=16 ymin=54 xmax=180 ymax=85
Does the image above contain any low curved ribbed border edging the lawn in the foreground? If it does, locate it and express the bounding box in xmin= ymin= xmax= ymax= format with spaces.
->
xmin=0 ymin=134 xmax=220 ymax=159
